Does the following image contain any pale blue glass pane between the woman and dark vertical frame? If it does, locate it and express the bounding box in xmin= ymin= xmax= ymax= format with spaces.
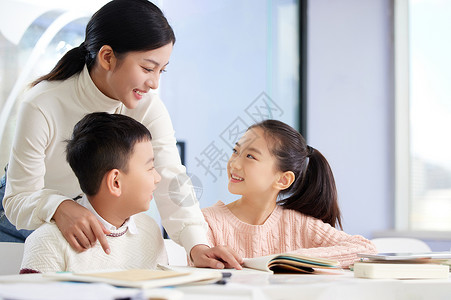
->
xmin=160 ymin=0 xmax=299 ymax=207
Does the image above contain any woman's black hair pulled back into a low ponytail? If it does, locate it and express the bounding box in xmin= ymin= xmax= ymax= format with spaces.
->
xmin=31 ymin=0 xmax=175 ymax=86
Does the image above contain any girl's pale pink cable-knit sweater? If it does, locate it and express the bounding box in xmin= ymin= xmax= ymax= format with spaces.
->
xmin=202 ymin=201 xmax=377 ymax=267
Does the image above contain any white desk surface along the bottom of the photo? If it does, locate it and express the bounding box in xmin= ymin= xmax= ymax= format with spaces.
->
xmin=0 ymin=271 xmax=451 ymax=300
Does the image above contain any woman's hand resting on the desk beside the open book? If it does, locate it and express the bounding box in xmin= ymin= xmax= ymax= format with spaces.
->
xmin=190 ymin=245 xmax=243 ymax=270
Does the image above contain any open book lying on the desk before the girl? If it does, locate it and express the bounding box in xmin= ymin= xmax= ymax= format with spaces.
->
xmin=243 ymin=253 xmax=340 ymax=274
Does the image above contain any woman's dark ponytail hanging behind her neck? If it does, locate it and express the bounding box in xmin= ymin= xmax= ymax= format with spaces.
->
xmin=31 ymin=42 xmax=93 ymax=86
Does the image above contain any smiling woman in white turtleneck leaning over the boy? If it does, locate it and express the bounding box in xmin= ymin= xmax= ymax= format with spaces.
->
xmin=0 ymin=0 xmax=240 ymax=268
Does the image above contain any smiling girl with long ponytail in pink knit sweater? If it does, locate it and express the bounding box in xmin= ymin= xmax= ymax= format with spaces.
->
xmin=203 ymin=120 xmax=376 ymax=267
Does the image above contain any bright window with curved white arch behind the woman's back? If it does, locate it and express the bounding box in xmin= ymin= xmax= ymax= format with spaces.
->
xmin=0 ymin=1 xmax=89 ymax=173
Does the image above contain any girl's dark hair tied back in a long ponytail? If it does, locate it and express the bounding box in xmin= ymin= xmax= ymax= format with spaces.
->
xmin=249 ymin=120 xmax=343 ymax=229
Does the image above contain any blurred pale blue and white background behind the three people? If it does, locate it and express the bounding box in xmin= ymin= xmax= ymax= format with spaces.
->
xmin=0 ymin=0 xmax=451 ymax=251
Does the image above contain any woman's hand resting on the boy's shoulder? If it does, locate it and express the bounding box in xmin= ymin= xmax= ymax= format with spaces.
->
xmin=53 ymin=199 xmax=111 ymax=254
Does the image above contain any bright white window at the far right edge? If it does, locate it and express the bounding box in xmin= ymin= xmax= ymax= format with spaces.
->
xmin=395 ymin=0 xmax=451 ymax=231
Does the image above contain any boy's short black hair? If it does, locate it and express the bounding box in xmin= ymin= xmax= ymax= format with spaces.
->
xmin=66 ymin=112 xmax=152 ymax=196
